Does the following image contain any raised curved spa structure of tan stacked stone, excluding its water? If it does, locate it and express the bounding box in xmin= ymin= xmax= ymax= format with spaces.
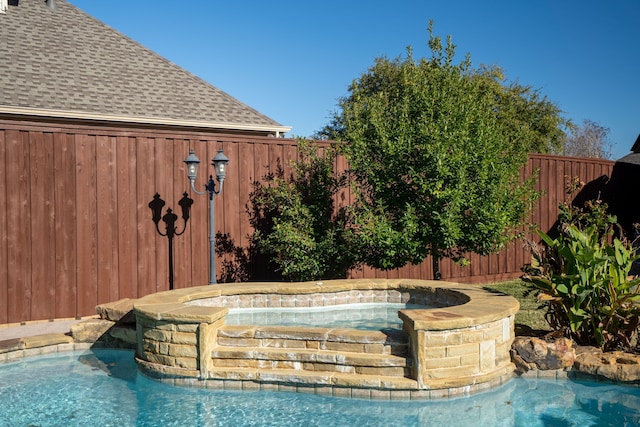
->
xmin=134 ymin=279 xmax=518 ymax=398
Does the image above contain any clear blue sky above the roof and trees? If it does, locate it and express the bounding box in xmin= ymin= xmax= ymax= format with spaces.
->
xmin=70 ymin=0 xmax=640 ymax=159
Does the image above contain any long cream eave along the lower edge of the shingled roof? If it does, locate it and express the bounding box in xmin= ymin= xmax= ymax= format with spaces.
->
xmin=0 ymin=105 xmax=291 ymax=137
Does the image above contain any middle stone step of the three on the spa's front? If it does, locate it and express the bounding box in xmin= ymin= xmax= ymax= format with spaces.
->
xmin=212 ymin=347 xmax=411 ymax=377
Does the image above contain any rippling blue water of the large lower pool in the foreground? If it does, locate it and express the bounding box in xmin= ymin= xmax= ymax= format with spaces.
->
xmin=0 ymin=350 xmax=640 ymax=427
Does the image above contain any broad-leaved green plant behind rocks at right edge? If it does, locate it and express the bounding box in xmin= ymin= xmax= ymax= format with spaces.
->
xmin=522 ymin=184 xmax=640 ymax=350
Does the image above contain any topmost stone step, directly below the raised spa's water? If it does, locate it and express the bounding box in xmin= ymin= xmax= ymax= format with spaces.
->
xmin=217 ymin=325 xmax=409 ymax=356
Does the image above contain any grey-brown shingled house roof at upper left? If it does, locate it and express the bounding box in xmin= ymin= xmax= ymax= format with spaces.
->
xmin=0 ymin=0 xmax=290 ymax=135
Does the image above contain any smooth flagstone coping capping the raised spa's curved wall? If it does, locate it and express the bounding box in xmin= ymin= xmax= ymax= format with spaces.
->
xmin=134 ymin=279 xmax=520 ymax=330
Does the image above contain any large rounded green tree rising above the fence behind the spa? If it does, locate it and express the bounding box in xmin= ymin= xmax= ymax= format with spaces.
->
xmin=336 ymin=23 xmax=536 ymax=278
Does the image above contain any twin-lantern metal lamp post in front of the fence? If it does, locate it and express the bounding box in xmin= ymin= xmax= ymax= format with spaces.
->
xmin=184 ymin=149 xmax=229 ymax=285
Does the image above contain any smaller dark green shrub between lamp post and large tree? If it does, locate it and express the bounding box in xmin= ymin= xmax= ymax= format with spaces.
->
xmin=249 ymin=140 xmax=356 ymax=281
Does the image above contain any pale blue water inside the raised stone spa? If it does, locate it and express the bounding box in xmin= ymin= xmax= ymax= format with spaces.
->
xmin=225 ymin=303 xmax=429 ymax=330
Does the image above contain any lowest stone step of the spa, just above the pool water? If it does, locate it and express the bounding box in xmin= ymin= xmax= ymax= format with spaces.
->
xmin=208 ymin=367 xmax=418 ymax=390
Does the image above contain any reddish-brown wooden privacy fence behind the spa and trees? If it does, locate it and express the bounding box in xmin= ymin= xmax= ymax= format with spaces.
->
xmin=0 ymin=120 xmax=613 ymax=324
